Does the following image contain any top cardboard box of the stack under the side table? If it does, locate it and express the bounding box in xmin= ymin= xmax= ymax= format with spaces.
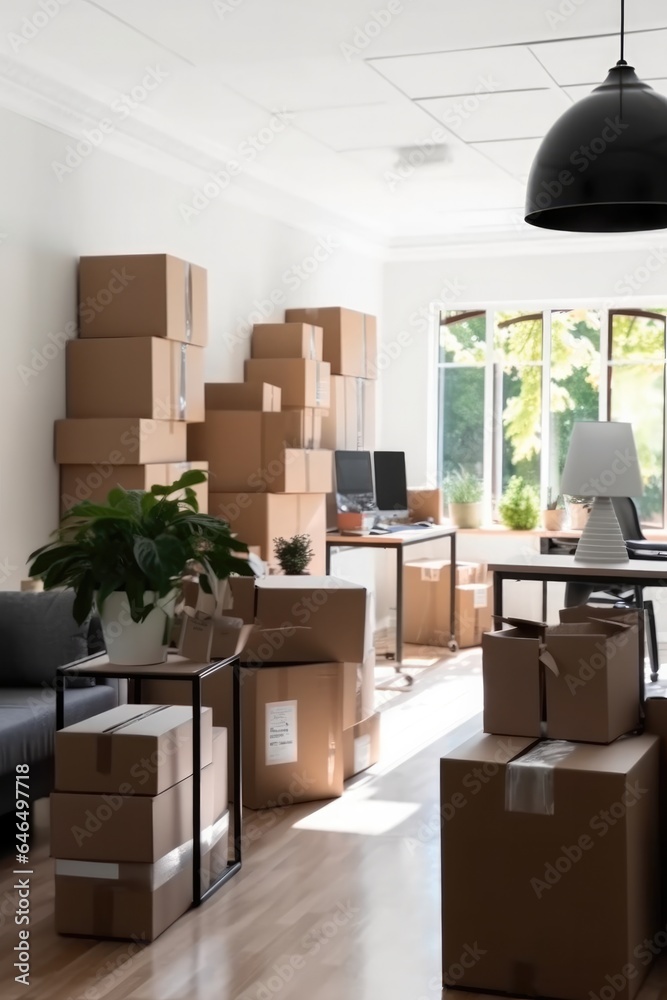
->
xmin=55 ymin=705 xmax=213 ymax=795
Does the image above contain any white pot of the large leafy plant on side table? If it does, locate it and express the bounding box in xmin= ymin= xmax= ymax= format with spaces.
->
xmin=98 ymin=591 xmax=178 ymax=666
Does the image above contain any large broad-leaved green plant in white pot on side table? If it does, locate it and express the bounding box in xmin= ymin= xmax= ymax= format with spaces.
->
xmin=29 ymin=469 xmax=254 ymax=665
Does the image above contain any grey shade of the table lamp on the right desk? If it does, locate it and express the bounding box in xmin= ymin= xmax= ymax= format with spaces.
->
xmin=560 ymin=420 xmax=644 ymax=497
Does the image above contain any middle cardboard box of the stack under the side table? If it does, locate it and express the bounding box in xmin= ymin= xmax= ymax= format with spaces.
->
xmin=51 ymin=764 xmax=214 ymax=864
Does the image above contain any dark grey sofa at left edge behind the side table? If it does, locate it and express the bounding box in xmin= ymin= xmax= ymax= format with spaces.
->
xmin=0 ymin=591 xmax=118 ymax=817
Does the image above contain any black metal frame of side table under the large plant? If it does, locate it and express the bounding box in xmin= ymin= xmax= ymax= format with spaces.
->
xmin=56 ymin=654 xmax=243 ymax=906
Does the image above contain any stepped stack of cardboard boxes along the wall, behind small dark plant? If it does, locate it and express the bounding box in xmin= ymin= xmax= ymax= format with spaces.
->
xmin=197 ymin=323 xmax=332 ymax=573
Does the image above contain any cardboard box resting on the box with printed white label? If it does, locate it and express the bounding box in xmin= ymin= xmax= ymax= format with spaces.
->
xmin=241 ymin=576 xmax=367 ymax=663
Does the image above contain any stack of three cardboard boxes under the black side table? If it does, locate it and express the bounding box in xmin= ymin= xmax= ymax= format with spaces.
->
xmin=51 ymin=705 xmax=229 ymax=941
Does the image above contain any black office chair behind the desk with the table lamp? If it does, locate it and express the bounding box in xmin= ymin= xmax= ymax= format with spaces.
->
xmin=565 ymin=497 xmax=667 ymax=681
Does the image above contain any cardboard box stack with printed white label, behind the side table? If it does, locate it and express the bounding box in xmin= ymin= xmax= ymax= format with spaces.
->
xmin=136 ymin=576 xmax=380 ymax=809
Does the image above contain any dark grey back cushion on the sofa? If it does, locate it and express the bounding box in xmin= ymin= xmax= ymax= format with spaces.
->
xmin=0 ymin=590 xmax=88 ymax=687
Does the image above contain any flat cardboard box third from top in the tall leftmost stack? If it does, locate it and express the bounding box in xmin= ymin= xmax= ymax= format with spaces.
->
xmin=55 ymin=417 xmax=187 ymax=465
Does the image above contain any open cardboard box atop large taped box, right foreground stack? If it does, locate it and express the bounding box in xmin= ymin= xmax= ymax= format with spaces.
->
xmin=441 ymin=607 xmax=667 ymax=1000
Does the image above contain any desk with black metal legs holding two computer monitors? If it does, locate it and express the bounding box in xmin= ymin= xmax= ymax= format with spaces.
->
xmin=326 ymin=524 xmax=458 ymax=685
